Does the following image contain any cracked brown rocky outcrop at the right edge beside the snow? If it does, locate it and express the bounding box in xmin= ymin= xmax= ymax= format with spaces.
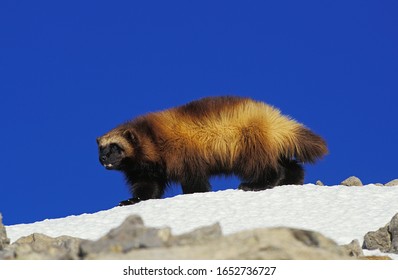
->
xmin=362 ymin=214 xmax=398 ymax=254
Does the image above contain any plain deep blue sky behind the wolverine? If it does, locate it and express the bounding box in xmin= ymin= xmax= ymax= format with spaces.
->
xmin=0 ymin=0 xmax=398 ymax=225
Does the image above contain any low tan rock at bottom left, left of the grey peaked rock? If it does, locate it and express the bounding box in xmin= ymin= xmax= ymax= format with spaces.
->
xmin=3 ymin=233 xmax=82 ymax=260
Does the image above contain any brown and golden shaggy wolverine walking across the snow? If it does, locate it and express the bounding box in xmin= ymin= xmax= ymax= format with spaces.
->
xmin=97 ymin=96 xmax=328 ymax=205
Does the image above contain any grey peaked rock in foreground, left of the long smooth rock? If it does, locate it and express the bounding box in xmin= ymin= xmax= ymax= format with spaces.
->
xmin=80 ymin=215 xmax=171 ymax=257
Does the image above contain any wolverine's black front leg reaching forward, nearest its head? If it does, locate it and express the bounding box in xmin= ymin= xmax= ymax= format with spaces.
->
xmin=119 ymin=179 xmax=166 ymax=206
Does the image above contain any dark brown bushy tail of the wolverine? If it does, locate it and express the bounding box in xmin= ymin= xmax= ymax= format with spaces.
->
xmin=295 ymin=126 xmax=328 ymax=163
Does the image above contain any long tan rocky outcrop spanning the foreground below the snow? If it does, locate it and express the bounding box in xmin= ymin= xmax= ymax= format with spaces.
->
xmin=0 ymin=216 xmax=362 ymax=260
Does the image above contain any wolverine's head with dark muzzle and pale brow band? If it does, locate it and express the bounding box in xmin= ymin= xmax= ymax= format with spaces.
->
xmin=97 ymin=130 xmax=135 ymax=170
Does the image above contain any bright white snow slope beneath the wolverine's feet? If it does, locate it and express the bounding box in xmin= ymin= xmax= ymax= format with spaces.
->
xmin=6 ymin=184 xmax=398 ymax=259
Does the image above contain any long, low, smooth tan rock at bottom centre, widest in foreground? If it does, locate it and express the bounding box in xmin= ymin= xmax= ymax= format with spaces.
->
xmin=89 ymin=228 xmax=353 ymax=260
